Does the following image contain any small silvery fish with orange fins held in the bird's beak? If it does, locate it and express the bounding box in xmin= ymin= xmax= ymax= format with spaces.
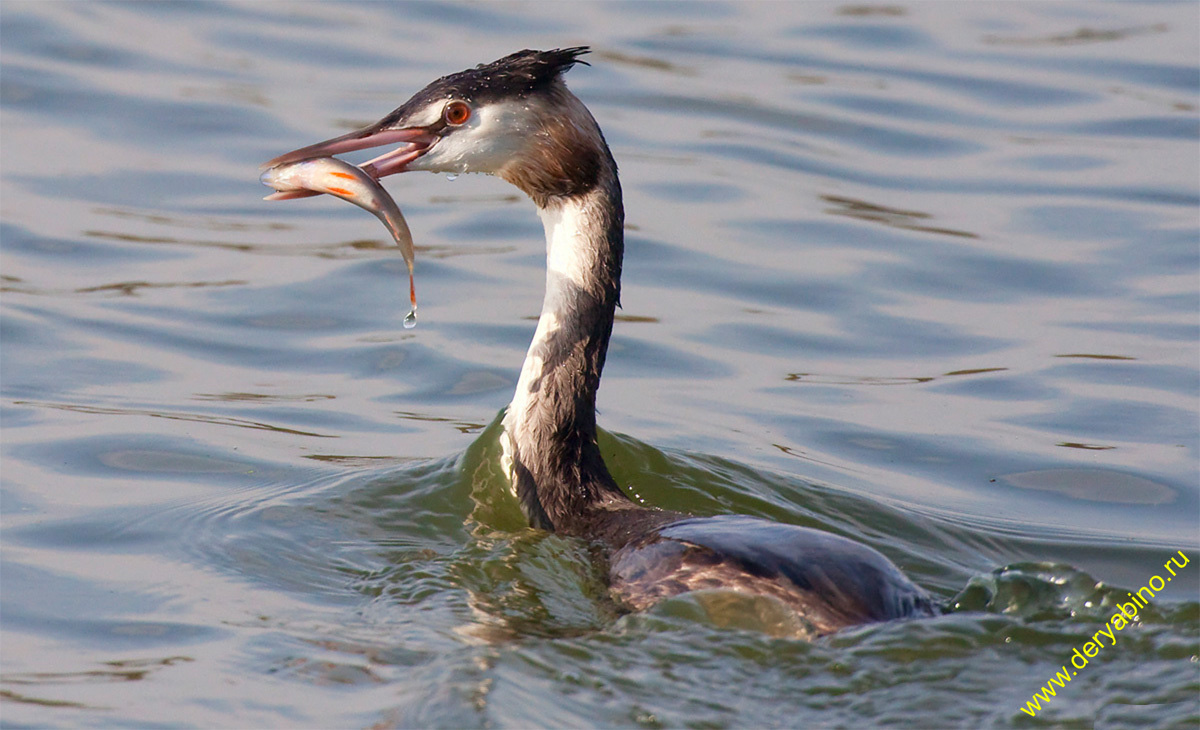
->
xmin=259 ymin=157 xmax=416 ymax=328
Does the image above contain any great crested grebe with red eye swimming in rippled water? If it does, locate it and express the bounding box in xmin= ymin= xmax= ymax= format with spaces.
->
xmin=268 ymin=47 xmax=938 ymax=635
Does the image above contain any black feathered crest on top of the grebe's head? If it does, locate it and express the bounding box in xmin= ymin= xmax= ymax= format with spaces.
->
xmin=384 ymin=46 xmax=590 ymax=122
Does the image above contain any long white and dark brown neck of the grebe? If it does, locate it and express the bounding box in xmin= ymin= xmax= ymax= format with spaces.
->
xmin=504 ymin=162 xmax=629 ymax=534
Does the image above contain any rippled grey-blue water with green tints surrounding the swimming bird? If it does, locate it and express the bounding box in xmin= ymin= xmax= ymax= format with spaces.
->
xmin=0 ymin=1 xmax=1200 ymax=728
